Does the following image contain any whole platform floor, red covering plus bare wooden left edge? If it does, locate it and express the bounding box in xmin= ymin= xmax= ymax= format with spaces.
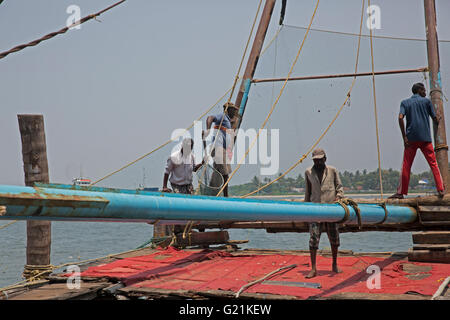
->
xmin=0 ymin=246 xmax=450 ymax=300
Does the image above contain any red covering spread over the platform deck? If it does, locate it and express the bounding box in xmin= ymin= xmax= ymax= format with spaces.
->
xmin=74 ymin=247 xmax=450 ymax=299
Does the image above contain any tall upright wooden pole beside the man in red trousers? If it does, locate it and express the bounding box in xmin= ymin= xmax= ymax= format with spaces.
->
xmin=424 ymin=0 xmax=449 ymax=193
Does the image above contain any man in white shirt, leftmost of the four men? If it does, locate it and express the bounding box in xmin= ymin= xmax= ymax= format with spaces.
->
xmin=162 ymin=138 xmax=204 ymax=194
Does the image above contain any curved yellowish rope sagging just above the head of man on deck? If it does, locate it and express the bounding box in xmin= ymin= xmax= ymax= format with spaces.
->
xmin=241 ymin=0 xmax=365 ymax=198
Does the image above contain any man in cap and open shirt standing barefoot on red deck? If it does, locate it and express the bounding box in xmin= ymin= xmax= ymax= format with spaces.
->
xmin=305 ymin=149 xmax=344 ymax=278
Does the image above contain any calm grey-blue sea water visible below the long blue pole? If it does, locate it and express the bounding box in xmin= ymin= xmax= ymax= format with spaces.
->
xmin=0 ymin=221 xmax=412 ymax=287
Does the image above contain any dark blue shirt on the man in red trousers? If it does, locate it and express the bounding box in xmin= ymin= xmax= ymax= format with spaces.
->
xmin=400 ymin=94 xmax=436 ymax=142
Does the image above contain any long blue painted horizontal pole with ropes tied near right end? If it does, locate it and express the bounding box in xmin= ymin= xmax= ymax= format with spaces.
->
xmin=0 ymin=185 xmax=417 ymax=225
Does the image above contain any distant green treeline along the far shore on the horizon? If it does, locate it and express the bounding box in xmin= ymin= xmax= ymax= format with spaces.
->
xmin=230 ymin=164 xmax=450 ymax=196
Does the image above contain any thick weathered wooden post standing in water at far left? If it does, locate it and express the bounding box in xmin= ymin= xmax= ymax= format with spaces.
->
xmin=17 ymin=115 xmax=51 ymax=278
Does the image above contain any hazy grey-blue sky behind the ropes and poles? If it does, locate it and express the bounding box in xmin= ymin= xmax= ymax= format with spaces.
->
xmin=0 ymin=0 xmax=450 ymax=187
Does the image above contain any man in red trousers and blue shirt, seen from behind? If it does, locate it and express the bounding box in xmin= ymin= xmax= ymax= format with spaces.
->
xmin=389 ymin=83 xmax=445 ymax=199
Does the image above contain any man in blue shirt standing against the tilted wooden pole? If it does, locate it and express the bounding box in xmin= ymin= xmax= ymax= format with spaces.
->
xmin=203 ymin=102 xmax=238 ymax=197
